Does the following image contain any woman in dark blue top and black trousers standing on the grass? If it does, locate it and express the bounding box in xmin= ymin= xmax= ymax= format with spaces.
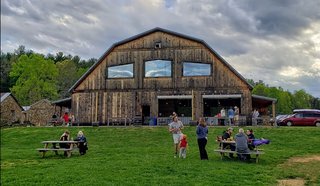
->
xmin=196 ymin=118 xmax=208 ymax=160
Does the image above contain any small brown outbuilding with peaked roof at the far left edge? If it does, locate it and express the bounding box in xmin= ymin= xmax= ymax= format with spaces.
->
xmin=0 ymin=92 xmax=23 ymax=126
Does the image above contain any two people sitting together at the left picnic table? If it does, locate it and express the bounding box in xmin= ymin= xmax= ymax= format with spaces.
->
xmin=59 ymin=130 xmax=88 ymax=156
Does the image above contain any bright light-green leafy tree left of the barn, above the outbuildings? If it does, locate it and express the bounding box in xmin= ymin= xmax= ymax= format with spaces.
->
xmin=9 ymin=53 xmax=58 ymax=105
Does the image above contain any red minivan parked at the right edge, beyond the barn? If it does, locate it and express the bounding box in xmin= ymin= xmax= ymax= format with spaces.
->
xmin=278 ymin=109 xmax=320 ymax=127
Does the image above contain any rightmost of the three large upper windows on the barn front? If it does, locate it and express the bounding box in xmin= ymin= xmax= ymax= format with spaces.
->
xmin=183 ymin=62 xmax=211 ymax=76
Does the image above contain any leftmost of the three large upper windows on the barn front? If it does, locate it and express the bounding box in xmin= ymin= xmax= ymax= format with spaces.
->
xmin=107 ymin=64 xmax=133 ymax=78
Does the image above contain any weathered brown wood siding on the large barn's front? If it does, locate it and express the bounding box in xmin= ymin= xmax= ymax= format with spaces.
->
xmin=72 ymin=32 xmax=251 ymax=123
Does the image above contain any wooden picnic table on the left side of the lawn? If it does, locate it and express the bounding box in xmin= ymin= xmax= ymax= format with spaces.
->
xmin=37 ymin=141 xmax=79 ymax=157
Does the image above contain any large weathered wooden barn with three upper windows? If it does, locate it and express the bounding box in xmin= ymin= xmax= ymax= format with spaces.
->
xmin=69 ymin=28 xmax=274 ymax=124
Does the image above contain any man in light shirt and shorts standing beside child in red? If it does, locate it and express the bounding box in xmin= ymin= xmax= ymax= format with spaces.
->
xmin=169 ymin=116 xmax=183 ymax=158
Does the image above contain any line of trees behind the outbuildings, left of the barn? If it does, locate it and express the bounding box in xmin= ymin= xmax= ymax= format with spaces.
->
xmin=1 ymin=46 xmax=97 ymax=105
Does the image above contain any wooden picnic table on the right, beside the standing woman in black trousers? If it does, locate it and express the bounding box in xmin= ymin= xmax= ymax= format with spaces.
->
xmin=214 ymin=140 xmax=264 ymax=163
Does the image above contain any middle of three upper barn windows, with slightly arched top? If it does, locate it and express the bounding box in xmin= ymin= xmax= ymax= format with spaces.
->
xmin=144 ymin=60 xmax=172 ymax=77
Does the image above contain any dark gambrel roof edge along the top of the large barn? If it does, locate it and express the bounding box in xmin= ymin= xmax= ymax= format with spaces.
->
xmin=69 ymin=27 xmax=253 ymax=92
